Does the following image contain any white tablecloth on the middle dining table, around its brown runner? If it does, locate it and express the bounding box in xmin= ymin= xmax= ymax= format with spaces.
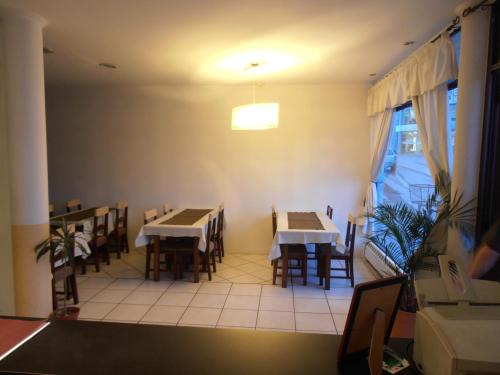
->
xmin=135 ymin=208 xmax=219 ymax=251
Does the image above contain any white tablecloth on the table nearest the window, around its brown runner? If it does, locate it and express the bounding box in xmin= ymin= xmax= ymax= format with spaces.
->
xmin=268 ymin=212 xmax=340 ymax=260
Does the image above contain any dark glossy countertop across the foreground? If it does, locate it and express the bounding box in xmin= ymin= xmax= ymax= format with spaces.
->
xmin=0 ymin=321 xmax=411 ymax=375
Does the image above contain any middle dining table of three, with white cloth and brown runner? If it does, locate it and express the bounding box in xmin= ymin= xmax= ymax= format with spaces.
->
xmin=135 ymin=208 xmax=219 ymax=283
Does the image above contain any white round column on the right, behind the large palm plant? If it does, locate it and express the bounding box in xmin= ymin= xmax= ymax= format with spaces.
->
xmin=448 ymin=1 xmax=490 ymax=266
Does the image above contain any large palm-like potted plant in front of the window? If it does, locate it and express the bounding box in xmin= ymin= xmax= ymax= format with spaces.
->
xmin=367 ymin=171 xmax=475 ymax=312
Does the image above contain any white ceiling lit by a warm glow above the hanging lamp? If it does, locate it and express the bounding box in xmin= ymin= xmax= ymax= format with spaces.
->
xmin=0 ymin=0 xmax=463 ymax=84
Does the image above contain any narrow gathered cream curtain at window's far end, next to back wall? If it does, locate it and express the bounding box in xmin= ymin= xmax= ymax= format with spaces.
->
xmin=363 ymin=109 xmax=392 ymax=233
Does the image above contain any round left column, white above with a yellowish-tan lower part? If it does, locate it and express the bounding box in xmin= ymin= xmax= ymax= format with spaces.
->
xmin=0 ymin=10 xmax=52 ymax=317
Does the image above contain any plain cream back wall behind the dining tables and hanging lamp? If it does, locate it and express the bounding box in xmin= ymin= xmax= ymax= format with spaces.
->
xmin=47 ymin=84 xmax=369 ymax=253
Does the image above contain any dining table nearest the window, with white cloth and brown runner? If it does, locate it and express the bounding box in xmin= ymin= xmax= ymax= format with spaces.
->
xmin=268 ymin=211 xmax=340 ymax=290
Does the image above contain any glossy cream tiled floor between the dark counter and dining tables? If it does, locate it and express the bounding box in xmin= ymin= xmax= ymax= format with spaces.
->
xmin=67 ymin=251 xmax=375 ymax=333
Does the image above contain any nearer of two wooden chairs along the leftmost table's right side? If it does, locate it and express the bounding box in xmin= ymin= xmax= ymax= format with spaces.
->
xmin=83 ymin=207 xmax=110 ymax=273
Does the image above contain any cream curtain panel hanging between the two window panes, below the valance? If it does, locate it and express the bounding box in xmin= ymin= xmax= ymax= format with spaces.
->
xmin=411 ymin=83 xmax=450 ymax=177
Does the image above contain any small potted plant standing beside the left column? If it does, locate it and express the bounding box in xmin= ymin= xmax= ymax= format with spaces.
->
xmin=35 ymin=219 xmax=89 ymax=319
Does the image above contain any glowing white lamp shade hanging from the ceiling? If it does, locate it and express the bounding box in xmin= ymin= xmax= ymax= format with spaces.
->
xmin=231 ymin=103 xmax=280 ymax=130
